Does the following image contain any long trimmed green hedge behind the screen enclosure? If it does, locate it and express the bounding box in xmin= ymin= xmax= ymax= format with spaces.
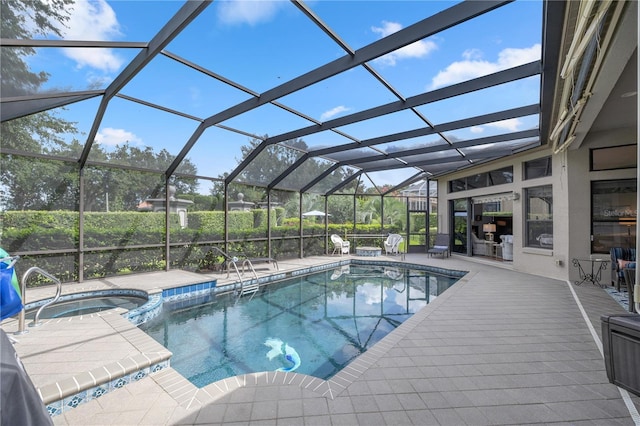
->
xmin=0 ymin=208 xmax=410 ymax=286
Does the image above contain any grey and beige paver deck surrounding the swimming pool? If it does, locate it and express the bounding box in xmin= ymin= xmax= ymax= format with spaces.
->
xmin=1 ymin=254 xmax=640 ymax=426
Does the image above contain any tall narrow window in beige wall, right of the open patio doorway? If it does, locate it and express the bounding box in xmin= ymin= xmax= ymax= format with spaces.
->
xmin=525 ymin=185 xmax=553 ymax=249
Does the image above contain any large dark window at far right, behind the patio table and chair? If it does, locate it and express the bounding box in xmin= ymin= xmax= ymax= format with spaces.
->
xmin=591 ymin=179 xmax=638 ymax=253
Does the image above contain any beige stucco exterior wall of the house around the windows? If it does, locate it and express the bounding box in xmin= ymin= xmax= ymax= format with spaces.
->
xmin=438 ymin=129 xmax=636 ymax=283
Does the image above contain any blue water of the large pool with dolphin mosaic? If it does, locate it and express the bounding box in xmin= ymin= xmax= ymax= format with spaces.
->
xmin=140 ymin=265 xmax=459 ymax=387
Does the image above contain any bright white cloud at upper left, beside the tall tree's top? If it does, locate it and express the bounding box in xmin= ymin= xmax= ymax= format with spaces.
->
xmin=64 ymin=0 xmax=124 ymax=72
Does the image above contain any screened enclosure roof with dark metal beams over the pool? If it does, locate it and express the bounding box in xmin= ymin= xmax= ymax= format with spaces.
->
xmin=1 ymin=0 xmax=564 ymax=194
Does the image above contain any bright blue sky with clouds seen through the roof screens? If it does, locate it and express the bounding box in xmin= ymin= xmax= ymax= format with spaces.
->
xmin=21 ymin=0 xmax=542 ymax=193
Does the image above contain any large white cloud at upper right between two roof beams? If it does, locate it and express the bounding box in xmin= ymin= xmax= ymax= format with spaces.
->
xmin=431 ymin=43 xmax=541 ymax=89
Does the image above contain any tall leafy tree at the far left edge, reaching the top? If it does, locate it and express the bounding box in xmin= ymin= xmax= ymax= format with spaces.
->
xmin=0 ymin=0 xmax=78 ymax=209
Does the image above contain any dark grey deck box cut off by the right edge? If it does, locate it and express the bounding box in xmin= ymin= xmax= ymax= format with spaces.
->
xmin=600 ymin=314 xmax=640 ymax=396
